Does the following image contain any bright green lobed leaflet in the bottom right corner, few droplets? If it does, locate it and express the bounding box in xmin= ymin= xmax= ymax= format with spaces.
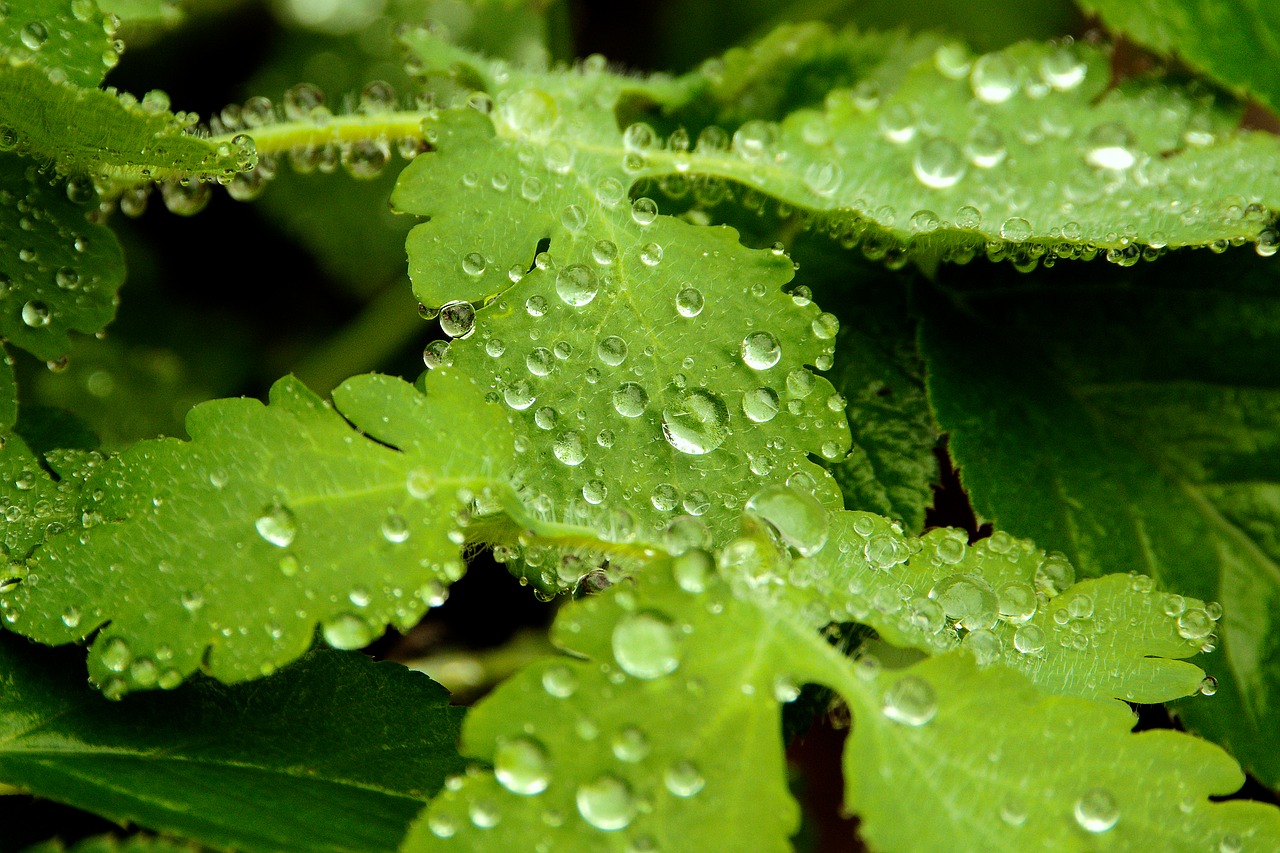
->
xmin=845 ymin=656 xmax=1280 ymax=853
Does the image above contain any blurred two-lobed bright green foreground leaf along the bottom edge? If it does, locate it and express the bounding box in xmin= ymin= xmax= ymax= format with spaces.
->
xmin=402 ymin=540 xmax=1280 ymax=853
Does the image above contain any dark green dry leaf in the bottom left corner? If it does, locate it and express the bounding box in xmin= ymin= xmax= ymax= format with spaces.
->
xmin=0 ymin=635 xmax=462 ymax=853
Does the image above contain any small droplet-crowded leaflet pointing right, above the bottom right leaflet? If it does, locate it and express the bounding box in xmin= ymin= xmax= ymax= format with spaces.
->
xmin=783 ymin=512 xmax=1215 ymax=703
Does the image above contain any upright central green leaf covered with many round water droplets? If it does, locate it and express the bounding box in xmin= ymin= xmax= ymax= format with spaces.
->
xmin=392 ymin=78 xmax=849 ymax=558
